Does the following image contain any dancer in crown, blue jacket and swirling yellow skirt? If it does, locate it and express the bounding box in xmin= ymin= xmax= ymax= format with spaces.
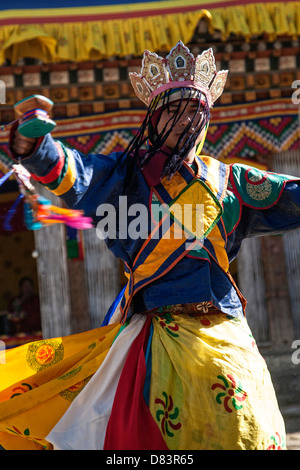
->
xmin=0 ymin=42 xmax=300 ymax=450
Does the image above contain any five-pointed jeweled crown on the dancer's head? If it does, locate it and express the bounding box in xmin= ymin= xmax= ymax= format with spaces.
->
xmin=129 ymin=41 xmax=228 ymax=108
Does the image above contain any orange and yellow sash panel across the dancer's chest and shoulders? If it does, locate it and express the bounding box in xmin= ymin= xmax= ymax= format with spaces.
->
xmin=121 ymin=157 xmax=228 ymax=321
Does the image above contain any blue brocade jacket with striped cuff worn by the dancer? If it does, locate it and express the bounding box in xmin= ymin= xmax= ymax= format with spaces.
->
xmin=17 ymin=134 xmax=300 ymax=316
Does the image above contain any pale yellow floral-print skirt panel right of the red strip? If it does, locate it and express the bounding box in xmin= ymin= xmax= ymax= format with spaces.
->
xmin=150 ymin=314 xmax=285 ymax=450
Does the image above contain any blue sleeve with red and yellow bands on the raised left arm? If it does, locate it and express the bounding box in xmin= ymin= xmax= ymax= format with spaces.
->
xmin=18 ymin=134 xmax=128 ymax=217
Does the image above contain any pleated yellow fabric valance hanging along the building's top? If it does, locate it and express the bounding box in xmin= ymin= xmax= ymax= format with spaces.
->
xmin=0 ymin=0 xmax=300 ymax=64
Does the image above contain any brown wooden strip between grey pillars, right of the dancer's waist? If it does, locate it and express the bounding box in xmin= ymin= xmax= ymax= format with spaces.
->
xmin=261 ymin=235 xmax=294 ymax=347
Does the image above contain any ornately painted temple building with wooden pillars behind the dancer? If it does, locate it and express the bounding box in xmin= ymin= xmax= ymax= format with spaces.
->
xmin=0 ymin=0 xmax=300 ymax=430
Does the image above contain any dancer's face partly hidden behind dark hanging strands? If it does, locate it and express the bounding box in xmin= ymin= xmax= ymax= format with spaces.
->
xmin=157 ymin=100 xmax=205 ymax=154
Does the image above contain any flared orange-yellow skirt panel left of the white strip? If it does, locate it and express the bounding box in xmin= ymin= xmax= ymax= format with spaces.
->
xmin=0 ymin=324 xmax=120 ymax=450
